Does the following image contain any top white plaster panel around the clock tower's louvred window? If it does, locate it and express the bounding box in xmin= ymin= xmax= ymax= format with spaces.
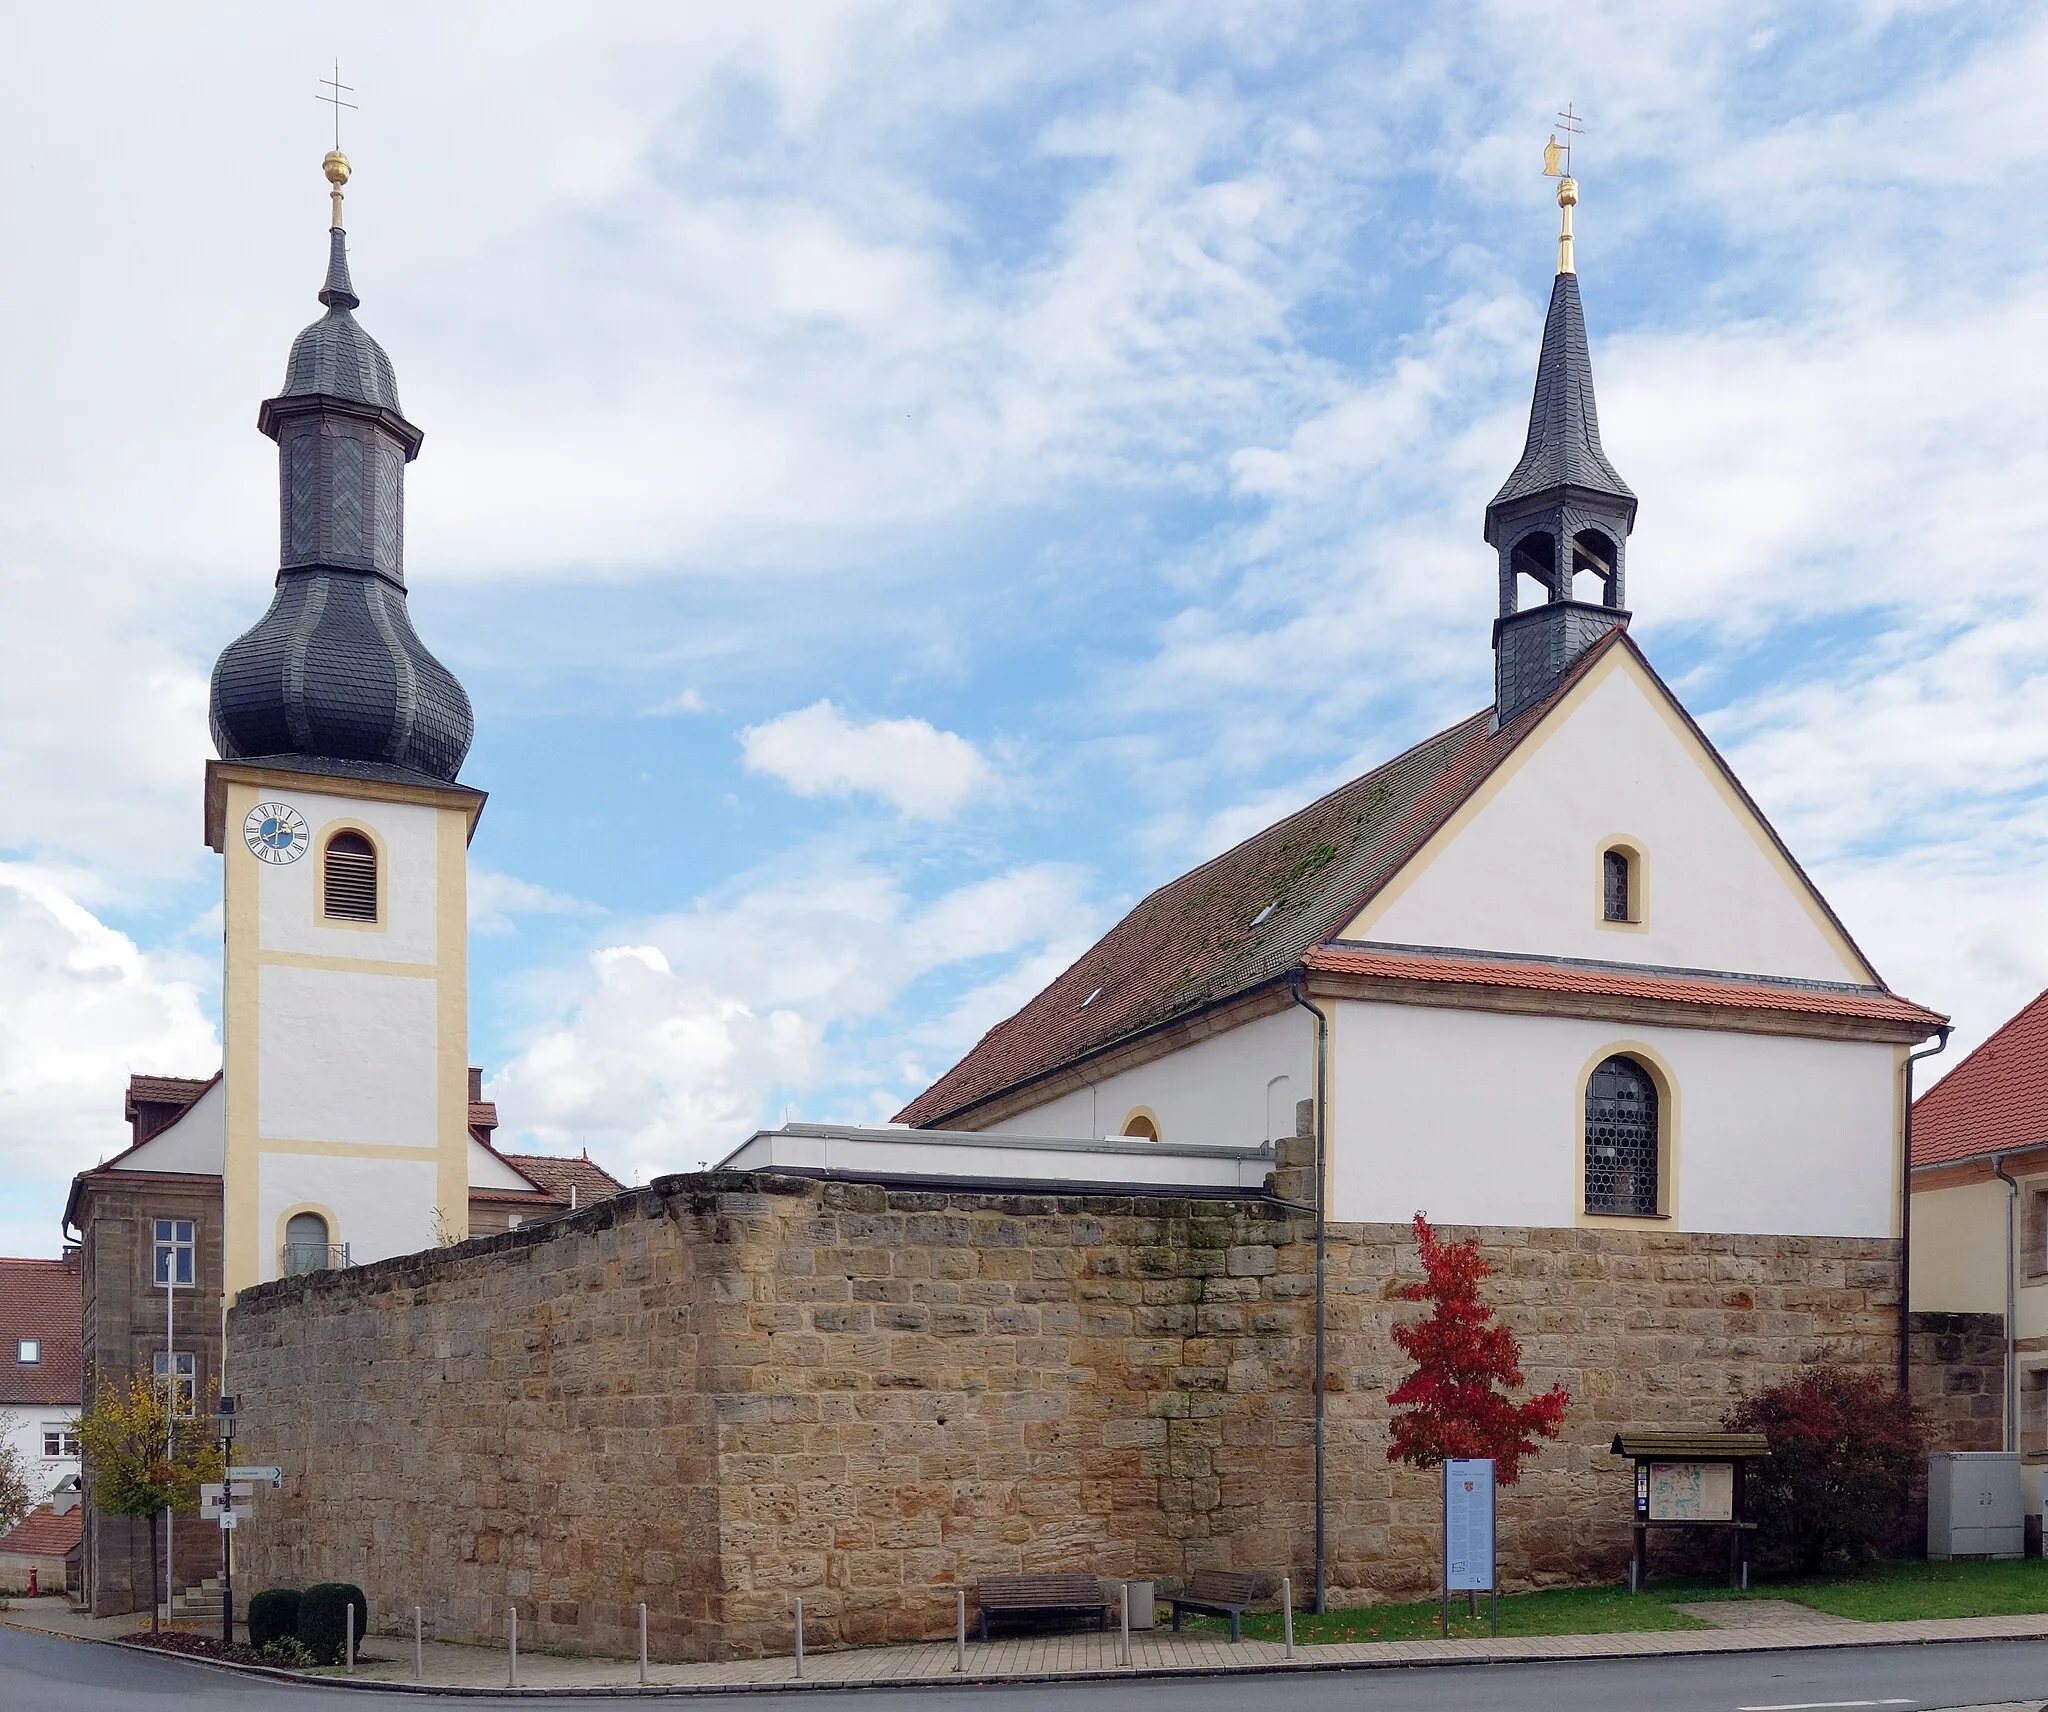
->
xmin=258 ymin=790 xmax=438 ymax=962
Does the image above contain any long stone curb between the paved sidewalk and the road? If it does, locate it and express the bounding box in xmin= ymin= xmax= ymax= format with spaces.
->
xmin=12 ymin=1620 xmax=2048 ymax=1712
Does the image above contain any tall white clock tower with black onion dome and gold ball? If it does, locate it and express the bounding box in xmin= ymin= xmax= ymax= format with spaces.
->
xmin=207 ymin=149 xmax=483 ymax=1300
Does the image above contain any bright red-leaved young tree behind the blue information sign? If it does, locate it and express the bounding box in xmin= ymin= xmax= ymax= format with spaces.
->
xmin=1386 ymin=1212 xmax=1571 ymax=1487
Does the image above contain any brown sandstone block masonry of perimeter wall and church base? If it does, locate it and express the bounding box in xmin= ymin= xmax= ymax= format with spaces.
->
xmin=227 ymin=1173 xmax=1896 ymax=1659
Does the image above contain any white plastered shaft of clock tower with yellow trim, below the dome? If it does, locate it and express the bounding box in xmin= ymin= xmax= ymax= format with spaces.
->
xmin=209 ymin=762 xmax=479 ymax=1298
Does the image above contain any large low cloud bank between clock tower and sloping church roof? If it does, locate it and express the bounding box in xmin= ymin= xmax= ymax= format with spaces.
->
xmin=492 ymin=860 xmax=1100 ymax=1173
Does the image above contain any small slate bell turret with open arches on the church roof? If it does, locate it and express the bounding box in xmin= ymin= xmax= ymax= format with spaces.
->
xmin=1487 ymin=163 xmax=1636 ymax=725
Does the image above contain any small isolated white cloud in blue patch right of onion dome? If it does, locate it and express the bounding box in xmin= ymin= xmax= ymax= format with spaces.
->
xmin=739 ymin=700 xmax=989 ymax=821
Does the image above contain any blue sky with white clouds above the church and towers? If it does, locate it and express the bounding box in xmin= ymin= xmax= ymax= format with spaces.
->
xmin=0 ymin=0 xmax=2048 ymax=1253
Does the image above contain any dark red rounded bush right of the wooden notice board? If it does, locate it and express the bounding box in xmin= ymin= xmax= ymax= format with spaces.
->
xmin=1729 ymin=1366 xmax=1927 ymax=1575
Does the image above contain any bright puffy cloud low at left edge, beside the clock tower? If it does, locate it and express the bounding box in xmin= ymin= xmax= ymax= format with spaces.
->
xmin=0 ymin=864 xmax=221 ymax=1253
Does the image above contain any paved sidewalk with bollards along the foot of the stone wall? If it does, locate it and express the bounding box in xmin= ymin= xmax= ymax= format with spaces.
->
xmin=12 ymin=1599 xmax=2048 ymax=1712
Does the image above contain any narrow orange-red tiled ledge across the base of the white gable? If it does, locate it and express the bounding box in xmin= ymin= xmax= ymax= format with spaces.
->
xmin=1303 ymin=944 xmax=1948 ymax=1034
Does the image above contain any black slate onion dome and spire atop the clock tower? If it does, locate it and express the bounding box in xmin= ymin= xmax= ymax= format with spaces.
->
xmin=211 ymin=149 xmax=473 ymax=782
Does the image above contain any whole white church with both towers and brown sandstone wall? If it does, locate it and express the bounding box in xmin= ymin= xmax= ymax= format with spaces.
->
xmin=86 ymin=160 xmax=1944 ymax=1659
